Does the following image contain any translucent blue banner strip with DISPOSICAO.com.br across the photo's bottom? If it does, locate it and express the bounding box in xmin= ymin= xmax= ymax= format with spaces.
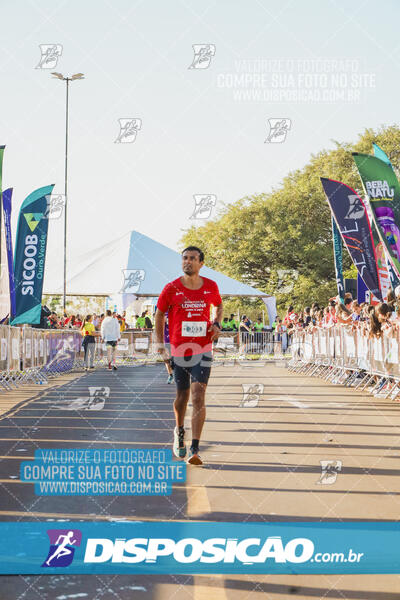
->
xmin=0 ymin=512 xmax=400 ymax=577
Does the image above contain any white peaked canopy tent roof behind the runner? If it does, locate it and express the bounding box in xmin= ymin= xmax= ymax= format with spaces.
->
xmin=44 ymin=231 xmax=269 ymax=298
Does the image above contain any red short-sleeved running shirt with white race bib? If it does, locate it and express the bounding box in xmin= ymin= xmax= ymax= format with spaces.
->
xmin=157 ymin=277 xmax=222 ymax=356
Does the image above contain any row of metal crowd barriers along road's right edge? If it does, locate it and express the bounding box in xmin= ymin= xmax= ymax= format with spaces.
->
xmin=288 ymin=326 xmax=400 ymax=399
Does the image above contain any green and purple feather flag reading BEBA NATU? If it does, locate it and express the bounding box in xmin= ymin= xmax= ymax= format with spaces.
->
xmin=353 ymin=152 xmax=400 ymax=278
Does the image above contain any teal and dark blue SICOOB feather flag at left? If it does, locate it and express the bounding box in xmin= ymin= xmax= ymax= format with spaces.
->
xmin=11 ymin=184 xmax=54 ymax=325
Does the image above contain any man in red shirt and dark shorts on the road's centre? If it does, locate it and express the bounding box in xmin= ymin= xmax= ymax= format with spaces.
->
xmin=155 ymin=246 xmax=223 ymax=465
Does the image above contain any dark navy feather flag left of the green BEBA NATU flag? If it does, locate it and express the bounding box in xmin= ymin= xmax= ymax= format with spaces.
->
xmin=321 ymin=177 xmax=382 ymax=301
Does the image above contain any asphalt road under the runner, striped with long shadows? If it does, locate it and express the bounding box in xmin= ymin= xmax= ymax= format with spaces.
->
xmin=0 ymin=364 xmax=400 ymax=600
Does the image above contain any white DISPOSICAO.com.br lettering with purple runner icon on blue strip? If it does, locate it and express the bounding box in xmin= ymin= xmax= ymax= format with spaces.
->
xmin=41 ymin=526 xmax=365 ymax=573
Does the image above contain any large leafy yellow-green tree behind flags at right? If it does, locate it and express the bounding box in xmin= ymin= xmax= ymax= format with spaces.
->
xmin=181 ymin=125 xmax=400 ymax=314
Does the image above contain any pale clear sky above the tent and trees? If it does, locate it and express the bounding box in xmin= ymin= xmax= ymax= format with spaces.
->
xmin=0 ymin=0 xmax=400 ymax=274
